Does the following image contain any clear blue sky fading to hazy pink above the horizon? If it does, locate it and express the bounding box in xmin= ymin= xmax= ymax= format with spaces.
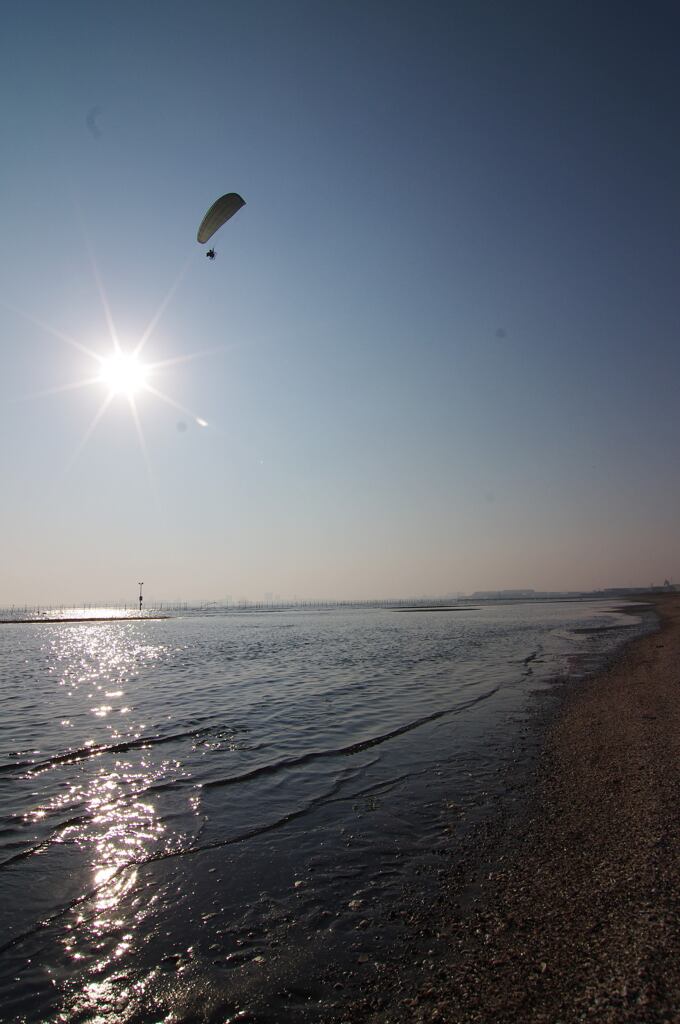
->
xmin=0 ymin=0 xmax=680 ymax=606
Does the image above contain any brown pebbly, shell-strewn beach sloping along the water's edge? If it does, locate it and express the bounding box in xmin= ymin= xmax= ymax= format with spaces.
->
xmin=346 ymin=595 xmax=680 ymax=1024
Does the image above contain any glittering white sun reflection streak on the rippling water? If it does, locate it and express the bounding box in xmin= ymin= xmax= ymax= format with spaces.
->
xmin=25 ymin=623 xmax=183 ymax=1024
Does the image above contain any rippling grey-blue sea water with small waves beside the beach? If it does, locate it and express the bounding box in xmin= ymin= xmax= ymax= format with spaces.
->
xmin=0 ymin=602 xmax=650 ymax=1024
